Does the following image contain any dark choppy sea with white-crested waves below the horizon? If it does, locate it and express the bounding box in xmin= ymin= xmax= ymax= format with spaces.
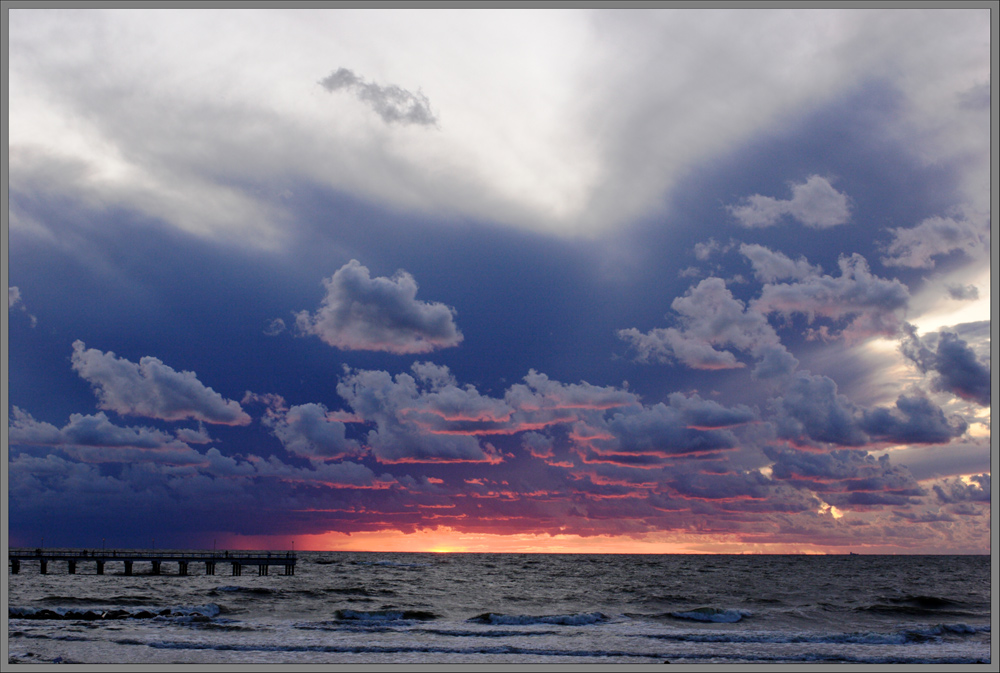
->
xmin=7 ymin=552 xmax=992 ymax=668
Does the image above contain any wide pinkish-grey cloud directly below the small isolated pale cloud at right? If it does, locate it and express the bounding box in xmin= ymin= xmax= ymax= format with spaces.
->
xmin=751 ymin=253 xmax=910 ymax=338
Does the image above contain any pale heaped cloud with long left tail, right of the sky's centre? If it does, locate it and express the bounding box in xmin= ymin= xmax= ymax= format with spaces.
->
xmin=618 ymin=277 xmax=797 ymax=378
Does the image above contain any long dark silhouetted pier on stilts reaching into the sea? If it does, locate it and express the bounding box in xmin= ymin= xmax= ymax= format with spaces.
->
xmin=7 ymin=548 xmax=296 ymax=575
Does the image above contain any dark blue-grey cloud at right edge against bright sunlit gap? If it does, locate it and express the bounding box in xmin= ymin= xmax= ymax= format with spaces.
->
xmin=900 ymin=323 xmax=991 ymax=407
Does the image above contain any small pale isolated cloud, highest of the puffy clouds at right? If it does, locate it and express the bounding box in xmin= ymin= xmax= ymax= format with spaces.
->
xmin=728 ymin=175 xmax=851 ymax=229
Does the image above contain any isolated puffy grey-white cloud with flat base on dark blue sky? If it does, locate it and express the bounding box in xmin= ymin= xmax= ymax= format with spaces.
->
xmin=296 ymin=259 xmax=463 ymax=354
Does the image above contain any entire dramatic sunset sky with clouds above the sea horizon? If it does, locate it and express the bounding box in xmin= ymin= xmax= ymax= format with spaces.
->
xmin=3 ymin=9 xmax=991 ymax=553
